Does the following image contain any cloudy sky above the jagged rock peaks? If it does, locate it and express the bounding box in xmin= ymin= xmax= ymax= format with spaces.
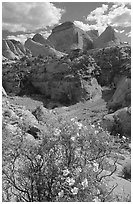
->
xmin=2 ymin=1 xmax=131 ymax=43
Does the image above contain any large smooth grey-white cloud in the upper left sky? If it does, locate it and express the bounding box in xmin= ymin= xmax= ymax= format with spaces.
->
xmin=2 ymin=2 xmax=65 ymax=32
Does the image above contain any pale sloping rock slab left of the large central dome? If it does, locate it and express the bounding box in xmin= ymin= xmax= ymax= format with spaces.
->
xmin=25 ymin=39 xmax=64 ymax=58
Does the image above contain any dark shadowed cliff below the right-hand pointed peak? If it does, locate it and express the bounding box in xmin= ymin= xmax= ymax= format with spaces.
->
xmin=88 ymin=45 xmax=131 ymax=86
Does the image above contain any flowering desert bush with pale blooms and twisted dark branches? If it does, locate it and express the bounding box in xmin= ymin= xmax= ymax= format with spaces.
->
xmin=3 ymin=115 xmax=117 ymax=202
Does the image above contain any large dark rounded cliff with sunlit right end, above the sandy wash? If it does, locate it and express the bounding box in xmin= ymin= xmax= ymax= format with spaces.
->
xmin=29 ymin=56 xmax=101 ymax=104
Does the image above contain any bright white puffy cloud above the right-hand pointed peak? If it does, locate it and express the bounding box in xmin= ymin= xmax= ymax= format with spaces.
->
xmin=86 ymin=2 xmax=131 ymax=33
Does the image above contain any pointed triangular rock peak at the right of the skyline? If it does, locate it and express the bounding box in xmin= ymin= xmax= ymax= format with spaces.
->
xmin=94 ymin=26 xmax=120 ymax=48
